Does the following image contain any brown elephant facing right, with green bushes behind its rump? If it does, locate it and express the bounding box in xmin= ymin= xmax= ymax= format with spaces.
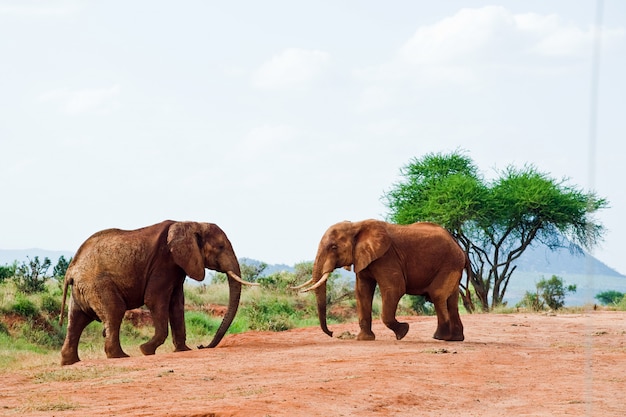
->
xmin=59 ymin=220 xmax=254 ymax=365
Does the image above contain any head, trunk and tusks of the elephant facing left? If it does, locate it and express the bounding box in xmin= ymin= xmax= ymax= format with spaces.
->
xmin=299 ymin=220 xmax=391 ymax=336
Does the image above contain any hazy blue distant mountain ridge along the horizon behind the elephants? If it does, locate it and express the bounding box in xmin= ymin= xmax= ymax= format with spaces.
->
xmin=0 ymin=246 xmax=626 ymax=278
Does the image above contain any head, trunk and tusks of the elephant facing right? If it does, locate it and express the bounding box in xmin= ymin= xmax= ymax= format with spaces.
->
xmin=167 ymin=222 xmax=257 ymax=348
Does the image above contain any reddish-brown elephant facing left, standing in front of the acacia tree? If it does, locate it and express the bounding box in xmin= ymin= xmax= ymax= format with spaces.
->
xmin=294 ymin=219 xmax=471 ymax=341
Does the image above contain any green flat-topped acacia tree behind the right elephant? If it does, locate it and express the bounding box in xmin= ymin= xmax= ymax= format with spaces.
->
xmin=383 ymin=151 xmax=608 ymax=311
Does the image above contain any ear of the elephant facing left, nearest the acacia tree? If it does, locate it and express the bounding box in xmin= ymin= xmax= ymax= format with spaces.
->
xmin=354 ymin=221 xmax=391 ymax=273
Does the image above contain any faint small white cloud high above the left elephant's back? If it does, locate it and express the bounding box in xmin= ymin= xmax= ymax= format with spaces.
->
xmin=38 ymin=85 xmax=120 ymax=115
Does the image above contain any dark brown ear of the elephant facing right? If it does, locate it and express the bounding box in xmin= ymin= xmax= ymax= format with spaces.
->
xmin=167 ymin=222 xmax=204 ymax=281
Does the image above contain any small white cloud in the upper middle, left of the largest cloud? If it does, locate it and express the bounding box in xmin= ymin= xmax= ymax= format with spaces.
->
xmin=252 ymin=48 xmax=330 ymax=90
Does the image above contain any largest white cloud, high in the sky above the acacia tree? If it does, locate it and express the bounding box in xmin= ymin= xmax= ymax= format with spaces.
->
xmin=357 ymin=6 xmax=624 ymax=88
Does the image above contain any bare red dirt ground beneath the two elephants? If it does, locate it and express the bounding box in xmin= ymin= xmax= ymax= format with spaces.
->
xmin=0 ymin=311 xmax=626 ymax=417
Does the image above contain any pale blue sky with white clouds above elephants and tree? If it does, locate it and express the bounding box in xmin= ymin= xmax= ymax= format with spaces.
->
xmin=0 ymin=0 xmax=626 ymax=274
